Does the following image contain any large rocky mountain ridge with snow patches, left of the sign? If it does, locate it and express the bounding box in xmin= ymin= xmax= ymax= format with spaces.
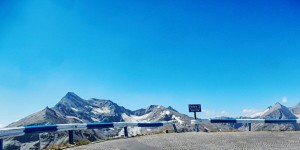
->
xmin=4 ymin=92 xmax=198 ymax=149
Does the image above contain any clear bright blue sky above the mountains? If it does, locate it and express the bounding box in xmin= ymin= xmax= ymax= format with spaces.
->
xmin=0 ymin=0 xmax=300 ymax=124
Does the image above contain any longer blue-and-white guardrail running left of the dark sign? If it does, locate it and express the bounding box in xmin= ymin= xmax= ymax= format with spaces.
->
xmin=0 ymin=120 xmax=177 ymax=150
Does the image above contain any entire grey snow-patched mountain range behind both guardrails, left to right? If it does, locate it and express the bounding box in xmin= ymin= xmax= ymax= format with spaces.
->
xmin=4 ymin=92 xmax=300 ymax=150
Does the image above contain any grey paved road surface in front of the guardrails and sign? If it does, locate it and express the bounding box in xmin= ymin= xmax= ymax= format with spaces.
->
xmin=68 ymin=132 xmax=300 ymax=150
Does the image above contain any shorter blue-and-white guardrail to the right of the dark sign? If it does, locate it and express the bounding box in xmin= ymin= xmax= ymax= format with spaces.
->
xmin=191 ymin=119 xmax=300 ymax=132
